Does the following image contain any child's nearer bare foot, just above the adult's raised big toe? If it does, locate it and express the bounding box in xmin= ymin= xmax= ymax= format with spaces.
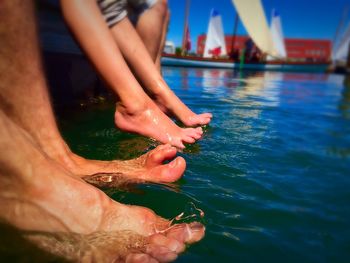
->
xmin=115 ymin=101 xmax=203 ymax=149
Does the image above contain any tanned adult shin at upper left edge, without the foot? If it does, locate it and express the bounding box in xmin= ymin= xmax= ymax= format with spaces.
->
xmin=0 ymin=0 xmax=68 ymax=161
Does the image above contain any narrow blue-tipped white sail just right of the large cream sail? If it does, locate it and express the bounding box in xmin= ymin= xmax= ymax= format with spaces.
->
xmin=270 ymin=9 xmax=287 ymax=58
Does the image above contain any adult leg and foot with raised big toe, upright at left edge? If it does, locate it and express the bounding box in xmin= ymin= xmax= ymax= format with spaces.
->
xmin=0 ymin=0 xmax=185 ymax=182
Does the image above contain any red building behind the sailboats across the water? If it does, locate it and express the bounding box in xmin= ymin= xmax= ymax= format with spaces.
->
xmin=197 ymin=34 xmax=332 ymax=61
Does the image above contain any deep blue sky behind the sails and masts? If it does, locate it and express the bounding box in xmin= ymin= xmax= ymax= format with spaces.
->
xmin=167 ymin=0 xmax=350 ymax=50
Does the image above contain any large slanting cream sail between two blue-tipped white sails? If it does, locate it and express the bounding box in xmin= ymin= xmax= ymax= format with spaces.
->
xmin=232 ymin=0 xmax=278 ymax=56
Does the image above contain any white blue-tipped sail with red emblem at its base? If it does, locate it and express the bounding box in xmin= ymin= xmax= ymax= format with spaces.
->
xmin=203 ymin=9 xmax=227 ymax=57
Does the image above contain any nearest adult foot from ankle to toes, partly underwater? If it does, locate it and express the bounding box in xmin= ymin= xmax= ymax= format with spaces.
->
xmin=0 ymin=162 xmax=205 ymax=262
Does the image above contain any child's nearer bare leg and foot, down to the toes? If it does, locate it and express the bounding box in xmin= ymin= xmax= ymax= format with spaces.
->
xmin=61 ymin=0 xmax=202 ymax=148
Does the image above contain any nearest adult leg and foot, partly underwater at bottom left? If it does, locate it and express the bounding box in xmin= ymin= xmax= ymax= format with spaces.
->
xmin=0 ymin=109 xmax=204 ymax=262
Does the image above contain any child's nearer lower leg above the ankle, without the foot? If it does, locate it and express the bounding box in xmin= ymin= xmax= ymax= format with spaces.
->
xmin=61 ymin=0 xmax=143 ymax=105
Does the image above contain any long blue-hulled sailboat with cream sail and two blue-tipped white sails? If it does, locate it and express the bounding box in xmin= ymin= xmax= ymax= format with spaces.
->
xmin=162 ymin=0 xmax=328 ymax=72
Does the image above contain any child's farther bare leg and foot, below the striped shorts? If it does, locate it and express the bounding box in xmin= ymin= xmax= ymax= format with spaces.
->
xmin=111 ymin=18 xmax=212 ymax=126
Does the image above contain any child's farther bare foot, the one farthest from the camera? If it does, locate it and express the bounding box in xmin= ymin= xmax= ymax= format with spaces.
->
xmin=155 ymin=89 xmax=213 ymax=127
